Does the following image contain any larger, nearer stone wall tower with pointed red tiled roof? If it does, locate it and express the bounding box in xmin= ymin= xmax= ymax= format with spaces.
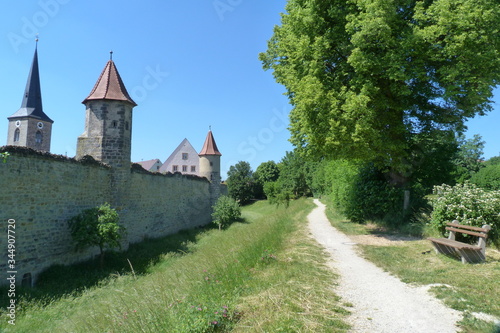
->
xmin=76 ymin=53 xmax=137 ymax=169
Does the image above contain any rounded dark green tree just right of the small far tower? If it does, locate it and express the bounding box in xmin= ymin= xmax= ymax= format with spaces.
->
xmin=226 ymin=161 xmax=254 ymax=205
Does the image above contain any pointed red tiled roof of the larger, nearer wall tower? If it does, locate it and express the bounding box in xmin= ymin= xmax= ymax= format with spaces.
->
xmin=82 ymin=60 xmax=137 ymax=106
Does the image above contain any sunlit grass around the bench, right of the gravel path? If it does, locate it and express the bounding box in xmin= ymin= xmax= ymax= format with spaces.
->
xmin=327 ymin=201 xmax=500 ymax=333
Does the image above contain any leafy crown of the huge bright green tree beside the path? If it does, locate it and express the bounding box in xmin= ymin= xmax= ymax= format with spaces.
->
xmin=260 ymin=0 xmax=500 ymax=181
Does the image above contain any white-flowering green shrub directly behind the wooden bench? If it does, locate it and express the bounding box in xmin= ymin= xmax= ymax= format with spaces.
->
xmin=431 ymin=183 xmax=500 ymax=247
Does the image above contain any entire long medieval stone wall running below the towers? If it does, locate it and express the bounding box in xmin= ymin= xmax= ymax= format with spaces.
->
xmin=0 ymin=148 xmax=213 ymax=284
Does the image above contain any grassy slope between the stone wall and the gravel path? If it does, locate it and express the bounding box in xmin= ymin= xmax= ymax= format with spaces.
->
xmin=0 ymin=200 xmax=347 ymax=333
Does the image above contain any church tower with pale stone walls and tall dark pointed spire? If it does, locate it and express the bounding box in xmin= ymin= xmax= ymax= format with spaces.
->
xmin=7 ymin=40 xmax=54 ymax=152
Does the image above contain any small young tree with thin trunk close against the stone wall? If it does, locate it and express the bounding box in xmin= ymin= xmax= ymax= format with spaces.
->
xmin=68 ymin=203 xmax=125 ymax=266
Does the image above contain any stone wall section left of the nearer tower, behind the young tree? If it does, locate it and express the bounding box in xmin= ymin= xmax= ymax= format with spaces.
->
xmin=0 ymin=148 xmax=111 ymax=283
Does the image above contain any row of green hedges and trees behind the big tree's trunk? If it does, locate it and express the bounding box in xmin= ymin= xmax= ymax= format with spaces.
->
xmin=227 ymin=132 xmax=500 ymax=227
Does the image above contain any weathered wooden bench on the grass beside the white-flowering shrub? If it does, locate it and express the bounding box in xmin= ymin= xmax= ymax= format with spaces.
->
xmin=427 ymin=220 xmax=491 ymax=264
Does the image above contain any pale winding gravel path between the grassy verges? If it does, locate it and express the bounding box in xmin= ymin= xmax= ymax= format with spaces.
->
xmin=308 ymin=200 xmax=461 ymax=333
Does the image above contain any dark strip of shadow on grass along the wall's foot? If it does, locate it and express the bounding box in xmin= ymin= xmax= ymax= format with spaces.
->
xmin=0 ymin=224 xmax=213 ymax=308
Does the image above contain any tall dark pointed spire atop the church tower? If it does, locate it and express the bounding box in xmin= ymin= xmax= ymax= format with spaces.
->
xmin=9 ymin=38 xmax=53 ymax=123
